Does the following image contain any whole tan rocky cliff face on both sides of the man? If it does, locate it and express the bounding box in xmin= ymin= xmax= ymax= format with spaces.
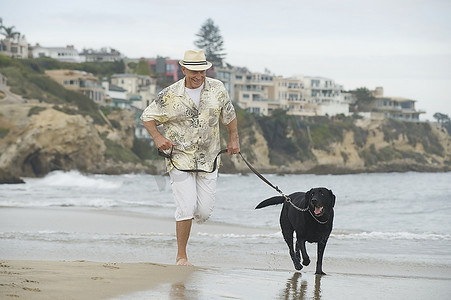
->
xmin=0 ymin=73 xmax=451 ymax=181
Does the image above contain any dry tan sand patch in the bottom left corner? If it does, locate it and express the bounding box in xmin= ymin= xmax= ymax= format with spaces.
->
xmin=0 ymin=260 xmax=194 ymax=300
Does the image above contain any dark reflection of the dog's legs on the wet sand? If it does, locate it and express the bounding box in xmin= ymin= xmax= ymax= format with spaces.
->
xmin=281 ymin=272 xmax=322 ymax=300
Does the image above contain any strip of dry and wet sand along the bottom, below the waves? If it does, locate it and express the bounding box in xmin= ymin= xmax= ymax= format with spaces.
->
xmin=0 ymin=260 xmax=451 ymax=300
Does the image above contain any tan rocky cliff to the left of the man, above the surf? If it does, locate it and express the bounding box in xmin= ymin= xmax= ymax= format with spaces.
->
xmin=0 ymin=96 xmax=155 ymax=182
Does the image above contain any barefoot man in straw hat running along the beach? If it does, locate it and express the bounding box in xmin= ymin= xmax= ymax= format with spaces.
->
xmin=141 ymin=50 xmax=240 ymax=266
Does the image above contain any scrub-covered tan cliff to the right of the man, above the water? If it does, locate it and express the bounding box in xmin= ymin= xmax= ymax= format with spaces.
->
xmin=220 ymin=112 xmax=451 ymax=174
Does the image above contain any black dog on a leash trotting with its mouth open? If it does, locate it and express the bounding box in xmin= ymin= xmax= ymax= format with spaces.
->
xmin=256 ymin=188 xmax=335 ymax=275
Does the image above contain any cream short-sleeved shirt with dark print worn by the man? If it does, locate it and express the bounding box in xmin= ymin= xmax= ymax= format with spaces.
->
xmin=141 ymin=77 xmax=236 ymax=171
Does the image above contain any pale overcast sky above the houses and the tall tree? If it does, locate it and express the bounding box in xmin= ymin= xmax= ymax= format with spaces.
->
xmin=0 ymin=0 xmax=451 ymax=121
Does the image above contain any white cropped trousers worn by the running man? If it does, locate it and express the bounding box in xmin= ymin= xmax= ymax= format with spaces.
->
xmin=169 ymin=169 xmax=218 ymax=223
